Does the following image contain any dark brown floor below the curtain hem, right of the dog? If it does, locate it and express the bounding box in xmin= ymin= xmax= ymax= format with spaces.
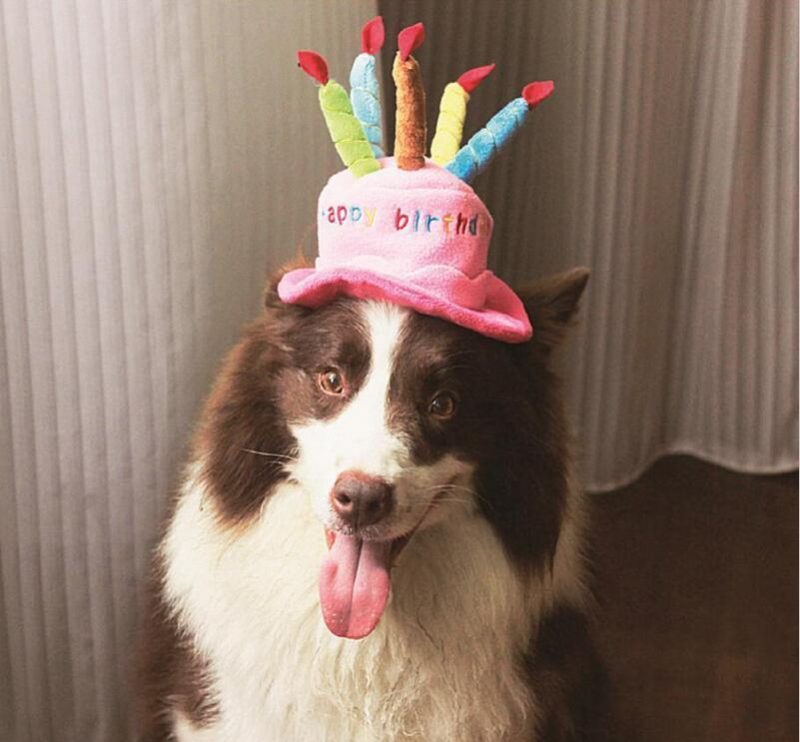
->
xmin=593 ymin=456 xmax=798 ymax=742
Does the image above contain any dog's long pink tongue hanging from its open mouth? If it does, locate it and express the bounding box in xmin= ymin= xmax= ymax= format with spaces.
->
xmin=319 ymin=533 xmax=392 ymax=639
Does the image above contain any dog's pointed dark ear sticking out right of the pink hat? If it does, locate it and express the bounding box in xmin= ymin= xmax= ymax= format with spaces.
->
xmin=517 ymin=268 xmax=589 ymax=354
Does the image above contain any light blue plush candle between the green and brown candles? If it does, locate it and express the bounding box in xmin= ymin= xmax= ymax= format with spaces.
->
xmin=350 ymin=16 xmax=384 ymax=157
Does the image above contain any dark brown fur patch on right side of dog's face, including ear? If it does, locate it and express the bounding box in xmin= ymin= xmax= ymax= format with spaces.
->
xmin=390 ymin=269 xmax=588 ymax=569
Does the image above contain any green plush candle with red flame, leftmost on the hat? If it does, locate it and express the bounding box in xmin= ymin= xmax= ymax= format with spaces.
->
xmin=297 ymin=51 xmax=381 ymax=178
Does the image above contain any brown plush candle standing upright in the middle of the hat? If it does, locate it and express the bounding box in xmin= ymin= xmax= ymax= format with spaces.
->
xmin=392 ymin=23 xmax=426 ymax=170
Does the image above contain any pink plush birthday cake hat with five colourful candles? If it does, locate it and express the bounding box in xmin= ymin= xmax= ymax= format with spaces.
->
xmin=278 ymin=16 xmax=553 ymax=343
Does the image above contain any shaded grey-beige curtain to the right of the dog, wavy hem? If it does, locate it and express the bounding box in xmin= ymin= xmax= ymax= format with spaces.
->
xmin=379 ymin=0 xmax=798 ymax=490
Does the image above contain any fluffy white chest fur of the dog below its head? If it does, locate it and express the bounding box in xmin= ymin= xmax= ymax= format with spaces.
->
xmin=163 ymin=484 xmax=534 ymax=742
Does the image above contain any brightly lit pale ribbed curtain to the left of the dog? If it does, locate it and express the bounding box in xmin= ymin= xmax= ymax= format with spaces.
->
xmin=0 ymin=0 xmax=375 ymax=742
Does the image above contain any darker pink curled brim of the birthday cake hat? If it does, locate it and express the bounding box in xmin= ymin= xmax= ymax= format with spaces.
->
xmin=278 ymin=267 xmax=533 ymax=343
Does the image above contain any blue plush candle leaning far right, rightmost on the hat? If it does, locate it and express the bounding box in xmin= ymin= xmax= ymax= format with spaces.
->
xmin=445 ymin=81 xmax=553 ymax=183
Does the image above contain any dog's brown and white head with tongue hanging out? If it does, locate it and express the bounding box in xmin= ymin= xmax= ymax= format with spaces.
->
xmin=198 ymin=269 xmax=588 ymax=638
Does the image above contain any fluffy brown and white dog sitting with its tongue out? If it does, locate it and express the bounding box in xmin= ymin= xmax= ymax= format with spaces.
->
xmin=141 ymin=269 xmax=607 ymax=742
